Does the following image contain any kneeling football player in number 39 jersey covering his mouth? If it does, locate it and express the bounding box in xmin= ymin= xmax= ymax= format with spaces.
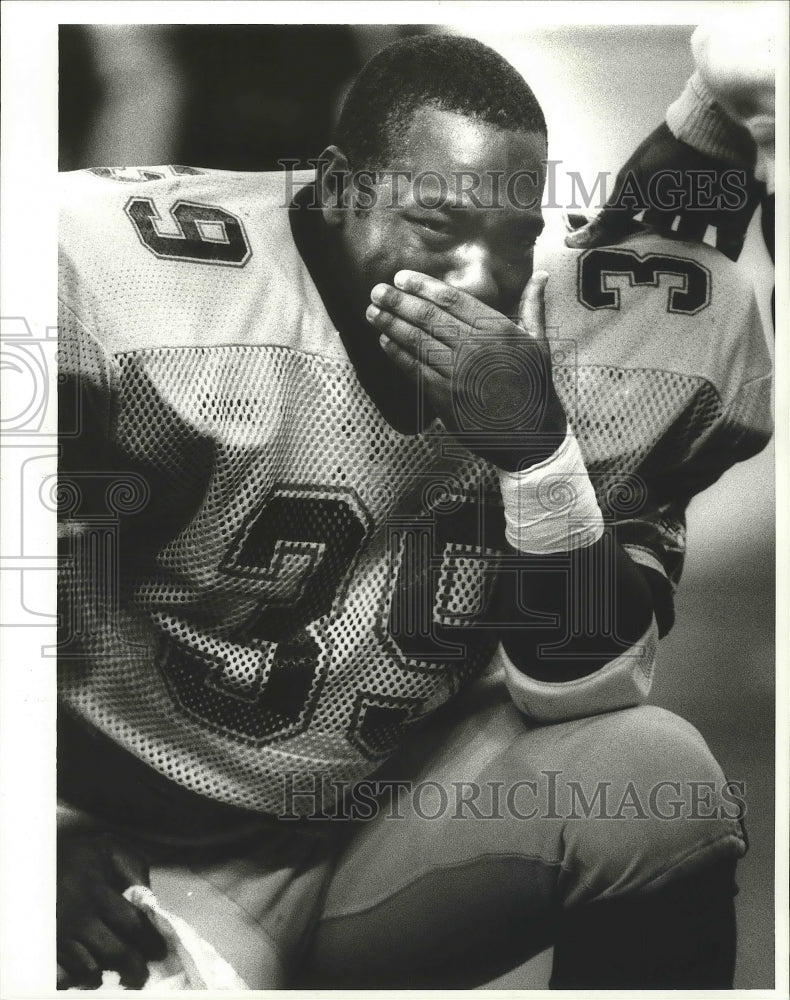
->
xmin=57 ymin=37 xmax=770 ymax=988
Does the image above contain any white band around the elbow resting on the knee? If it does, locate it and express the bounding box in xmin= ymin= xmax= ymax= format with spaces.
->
xmin=500 ymin=618 xmax=658 ymax=722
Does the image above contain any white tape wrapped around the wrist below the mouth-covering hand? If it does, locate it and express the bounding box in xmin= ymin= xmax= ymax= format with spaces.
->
xmin=498 ymin=431 xmax=603 ymax=554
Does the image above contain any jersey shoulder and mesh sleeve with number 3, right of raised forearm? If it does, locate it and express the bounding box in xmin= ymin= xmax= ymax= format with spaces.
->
xmin=536 ymin=231 xmax=772 ymax=588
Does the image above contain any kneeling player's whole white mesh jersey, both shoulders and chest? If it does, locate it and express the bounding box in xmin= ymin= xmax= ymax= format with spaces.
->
xmin=59 ymin=167 xmax=769 ymax=814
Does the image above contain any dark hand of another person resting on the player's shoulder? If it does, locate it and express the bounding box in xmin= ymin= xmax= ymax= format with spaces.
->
xmin=565 ymin=122 xmax=763 ymax=260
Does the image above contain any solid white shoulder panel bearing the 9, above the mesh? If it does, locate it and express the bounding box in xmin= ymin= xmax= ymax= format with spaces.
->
xmin=59 ymin=166 xmax=340 ymax=360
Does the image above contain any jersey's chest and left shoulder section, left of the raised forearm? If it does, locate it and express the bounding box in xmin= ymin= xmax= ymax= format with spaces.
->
xmin=60 ymin=168 xmax=502 ymax=813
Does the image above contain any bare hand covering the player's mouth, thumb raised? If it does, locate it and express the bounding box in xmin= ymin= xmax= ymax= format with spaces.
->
xmin=366 ymin=271 xmax=566 ymax=470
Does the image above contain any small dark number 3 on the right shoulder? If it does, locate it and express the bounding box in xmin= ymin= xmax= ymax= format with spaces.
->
xmin=578 ymin=247 xmax=711 ymax=316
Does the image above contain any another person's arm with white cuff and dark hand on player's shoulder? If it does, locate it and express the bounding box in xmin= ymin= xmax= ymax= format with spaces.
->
xmin=566 ymin=14 xmax=775 ymax=260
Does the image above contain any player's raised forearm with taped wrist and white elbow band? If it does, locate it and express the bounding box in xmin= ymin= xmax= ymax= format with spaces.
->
xmin=499 ymin=426 xmax=658 ymax=721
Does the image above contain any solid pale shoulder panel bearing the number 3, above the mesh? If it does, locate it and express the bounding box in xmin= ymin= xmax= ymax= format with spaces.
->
xmin=539 ymin=232 xmax=771 ymax=399
